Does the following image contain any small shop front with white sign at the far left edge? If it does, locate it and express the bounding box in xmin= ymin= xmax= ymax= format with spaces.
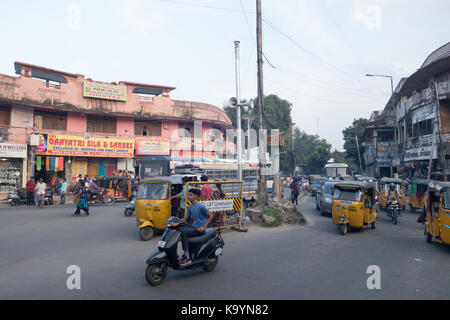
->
xmin=0 ymin=143 xmax=27 ymax=196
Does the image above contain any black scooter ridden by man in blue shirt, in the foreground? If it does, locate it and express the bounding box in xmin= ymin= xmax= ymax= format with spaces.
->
xmin=145 ymin=217 xmax=225 ymax=286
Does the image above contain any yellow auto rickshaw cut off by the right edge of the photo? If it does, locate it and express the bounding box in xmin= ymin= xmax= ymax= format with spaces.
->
xmin=425 ymin=181 xmax=450 ymax=245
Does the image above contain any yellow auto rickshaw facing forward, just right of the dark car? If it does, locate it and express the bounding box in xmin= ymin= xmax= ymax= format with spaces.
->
xmin=332 ymin=181 xmax=377 ymax=235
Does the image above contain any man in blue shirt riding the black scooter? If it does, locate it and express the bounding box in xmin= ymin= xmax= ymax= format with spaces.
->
xmin=178 ymin=189 xmax=214 ymax=266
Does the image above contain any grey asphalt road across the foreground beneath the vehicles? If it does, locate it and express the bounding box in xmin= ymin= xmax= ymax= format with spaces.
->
xmin=0 ymin=196 xmax=450 ymax=300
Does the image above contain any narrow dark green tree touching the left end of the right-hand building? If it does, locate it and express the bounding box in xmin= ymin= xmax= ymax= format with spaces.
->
xmin=342 ymin=118 xmax=369 ymax=168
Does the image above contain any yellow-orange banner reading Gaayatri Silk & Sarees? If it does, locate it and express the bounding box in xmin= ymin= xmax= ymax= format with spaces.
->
xmin=36 ymin=134 xmax=134 ymax=158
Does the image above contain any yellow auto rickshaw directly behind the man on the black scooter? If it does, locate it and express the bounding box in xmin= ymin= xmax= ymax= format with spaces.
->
xmin=135 ymin=176 xmax=183 ymax=241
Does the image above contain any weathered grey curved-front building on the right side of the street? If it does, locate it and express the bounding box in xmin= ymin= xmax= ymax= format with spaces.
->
xmin=366 ymin=43 xmax=450 ymax=180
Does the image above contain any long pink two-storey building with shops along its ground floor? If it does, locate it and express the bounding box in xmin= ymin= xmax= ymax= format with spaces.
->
xmin=0 ymin=62 xmax=235 ymax=193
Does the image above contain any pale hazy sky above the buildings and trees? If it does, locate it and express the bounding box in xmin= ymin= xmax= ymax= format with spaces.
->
xmin=0 ymin=0 xmax=450 ymax=151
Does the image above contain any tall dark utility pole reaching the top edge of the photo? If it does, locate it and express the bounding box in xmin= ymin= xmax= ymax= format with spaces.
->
xmin=256 ymin=0 xmax=267 ymax=205
